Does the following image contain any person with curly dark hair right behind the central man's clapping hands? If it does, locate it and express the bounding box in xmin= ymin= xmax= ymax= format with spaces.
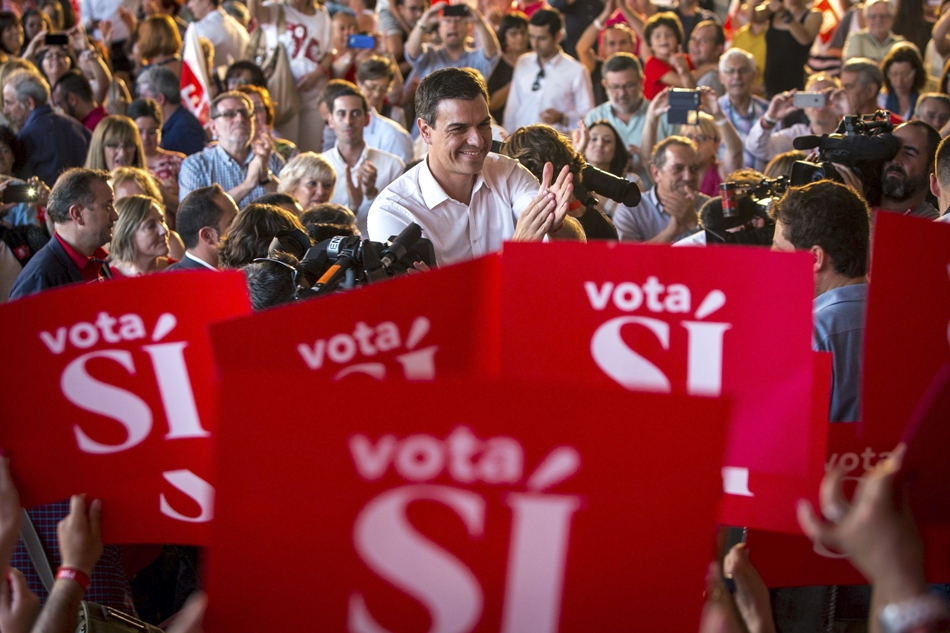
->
xmin=501 ymin=123 xmax=617 ymax=240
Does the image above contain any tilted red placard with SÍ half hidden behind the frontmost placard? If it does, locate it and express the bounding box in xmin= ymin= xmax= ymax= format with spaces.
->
xmin=211 ymin=256 xmax=500 ymax=381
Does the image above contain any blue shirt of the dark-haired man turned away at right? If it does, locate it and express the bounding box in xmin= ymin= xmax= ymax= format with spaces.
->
xmin=812 ymin=283 xmax=868 ymax=422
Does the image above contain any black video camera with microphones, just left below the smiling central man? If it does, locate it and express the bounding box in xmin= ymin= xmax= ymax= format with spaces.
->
xmin=268 ymin=223 xmax=436 ymax=300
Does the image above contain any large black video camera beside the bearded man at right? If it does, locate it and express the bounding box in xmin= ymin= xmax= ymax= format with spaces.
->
xmin=791 ymin=110 xmax=900 ymax=206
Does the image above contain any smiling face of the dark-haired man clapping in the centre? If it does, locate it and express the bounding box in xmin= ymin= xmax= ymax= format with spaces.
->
xmin=419 ymin=96 xmax=491 ymax=177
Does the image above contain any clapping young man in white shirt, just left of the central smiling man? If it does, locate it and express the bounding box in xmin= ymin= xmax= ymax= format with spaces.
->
xmin=322 ymin=84 xmax=406 ymax=233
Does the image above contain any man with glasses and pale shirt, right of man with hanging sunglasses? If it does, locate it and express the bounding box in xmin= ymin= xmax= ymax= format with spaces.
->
xmin=584 ymin=53 xmax=673 ymax=182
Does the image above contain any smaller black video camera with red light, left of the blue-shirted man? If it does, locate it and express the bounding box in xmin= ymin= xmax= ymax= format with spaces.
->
xmin=699 ymin=176 xmax=788 ymax=246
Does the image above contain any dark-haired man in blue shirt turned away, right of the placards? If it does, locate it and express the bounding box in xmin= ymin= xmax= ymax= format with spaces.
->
xmin=770 ymin=180 xmax=870 ymax=422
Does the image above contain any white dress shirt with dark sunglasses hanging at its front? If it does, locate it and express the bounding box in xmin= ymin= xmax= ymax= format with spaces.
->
xmin=504 ymin=50 xmax=594 ymax=134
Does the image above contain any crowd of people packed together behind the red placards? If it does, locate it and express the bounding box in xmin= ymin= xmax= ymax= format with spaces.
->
xmin=0 ymin=0 xmax=950 ymax=633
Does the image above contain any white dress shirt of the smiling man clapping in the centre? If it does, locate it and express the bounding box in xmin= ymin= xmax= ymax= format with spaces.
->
xmin=369 ymin=154 xmax=540 ymax=266
